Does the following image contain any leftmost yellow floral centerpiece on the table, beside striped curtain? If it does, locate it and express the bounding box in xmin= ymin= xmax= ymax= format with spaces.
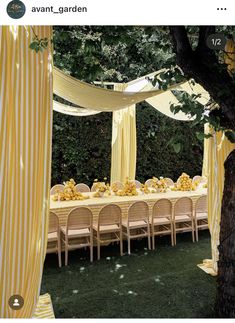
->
xmin=52 ymin=178 xmax=89 ymax=201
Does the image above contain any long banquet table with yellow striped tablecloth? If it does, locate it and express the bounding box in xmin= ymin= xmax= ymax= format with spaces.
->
xmin=50 ymin=188 xmax=207 ymax=226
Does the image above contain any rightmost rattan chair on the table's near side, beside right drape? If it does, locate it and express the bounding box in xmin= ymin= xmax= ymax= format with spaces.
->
xmin=194 ymin=196 xmax=208 ymax=241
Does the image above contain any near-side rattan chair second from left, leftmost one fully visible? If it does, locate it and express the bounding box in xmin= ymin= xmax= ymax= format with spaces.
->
xmin=61 ymin=207 xmax=93 ymax=266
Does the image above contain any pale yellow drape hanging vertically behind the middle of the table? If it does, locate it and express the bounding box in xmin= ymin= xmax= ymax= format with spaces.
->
xmin=110 ymin=84 xmax=136 ymax=183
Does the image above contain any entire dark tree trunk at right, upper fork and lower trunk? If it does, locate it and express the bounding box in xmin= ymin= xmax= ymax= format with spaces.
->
xmin=170 ymin=26 xmax=235 ymax=318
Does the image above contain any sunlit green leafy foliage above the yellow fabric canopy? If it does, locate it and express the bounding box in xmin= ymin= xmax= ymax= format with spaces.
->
xmin=54 ymin=26 xmax=174 ymax=82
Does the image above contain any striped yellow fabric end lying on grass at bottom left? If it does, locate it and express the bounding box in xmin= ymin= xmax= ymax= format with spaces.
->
xmin=33 ymin=294 xmax=55 ymax=319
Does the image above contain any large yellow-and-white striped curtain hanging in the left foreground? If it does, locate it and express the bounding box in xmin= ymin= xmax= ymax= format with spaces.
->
xmin=0 ymin=26 xmax=52 ymax=318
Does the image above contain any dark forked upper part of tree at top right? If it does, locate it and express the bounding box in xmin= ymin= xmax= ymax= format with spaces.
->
xmin=170 ymin=26 xmax=235 ymax=130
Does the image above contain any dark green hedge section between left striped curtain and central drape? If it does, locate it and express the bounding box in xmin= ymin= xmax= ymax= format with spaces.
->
xmin=51 ymin=112 xmax=112 ymax=185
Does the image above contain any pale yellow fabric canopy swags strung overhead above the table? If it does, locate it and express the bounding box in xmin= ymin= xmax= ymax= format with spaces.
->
xmin=54 ymin=68 xmax=209 ymax=121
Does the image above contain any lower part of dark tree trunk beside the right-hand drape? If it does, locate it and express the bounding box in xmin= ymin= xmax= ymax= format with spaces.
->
xmin=216 ymin=150 xmax=235 ymax=318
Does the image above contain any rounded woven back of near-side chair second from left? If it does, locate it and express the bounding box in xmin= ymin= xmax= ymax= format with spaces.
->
xmin=66 ymin=207 xmax=93 ymax=232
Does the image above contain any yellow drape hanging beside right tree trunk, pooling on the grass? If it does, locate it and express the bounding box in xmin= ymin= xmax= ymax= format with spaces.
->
xmin=199 ymin=132 xmax=235 ymax=275
